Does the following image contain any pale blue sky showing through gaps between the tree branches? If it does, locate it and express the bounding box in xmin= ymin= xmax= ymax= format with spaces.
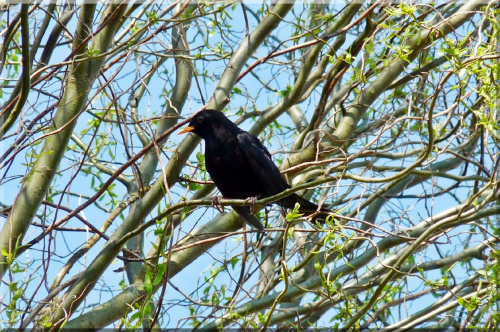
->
xmin=0 ymin=2 xmax=492 ymax=327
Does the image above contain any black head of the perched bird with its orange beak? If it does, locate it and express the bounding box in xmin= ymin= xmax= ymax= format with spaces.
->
xmin=178 ymin=110 xmax=237 ymax=139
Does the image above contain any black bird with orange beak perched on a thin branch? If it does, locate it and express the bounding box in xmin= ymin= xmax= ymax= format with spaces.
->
xmin=179 ymin=110 xmax=329 ymax=231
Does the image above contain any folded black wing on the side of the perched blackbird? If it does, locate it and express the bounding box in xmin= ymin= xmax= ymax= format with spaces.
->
xmin=238 ymin=131 xmax=290 ymax=196
